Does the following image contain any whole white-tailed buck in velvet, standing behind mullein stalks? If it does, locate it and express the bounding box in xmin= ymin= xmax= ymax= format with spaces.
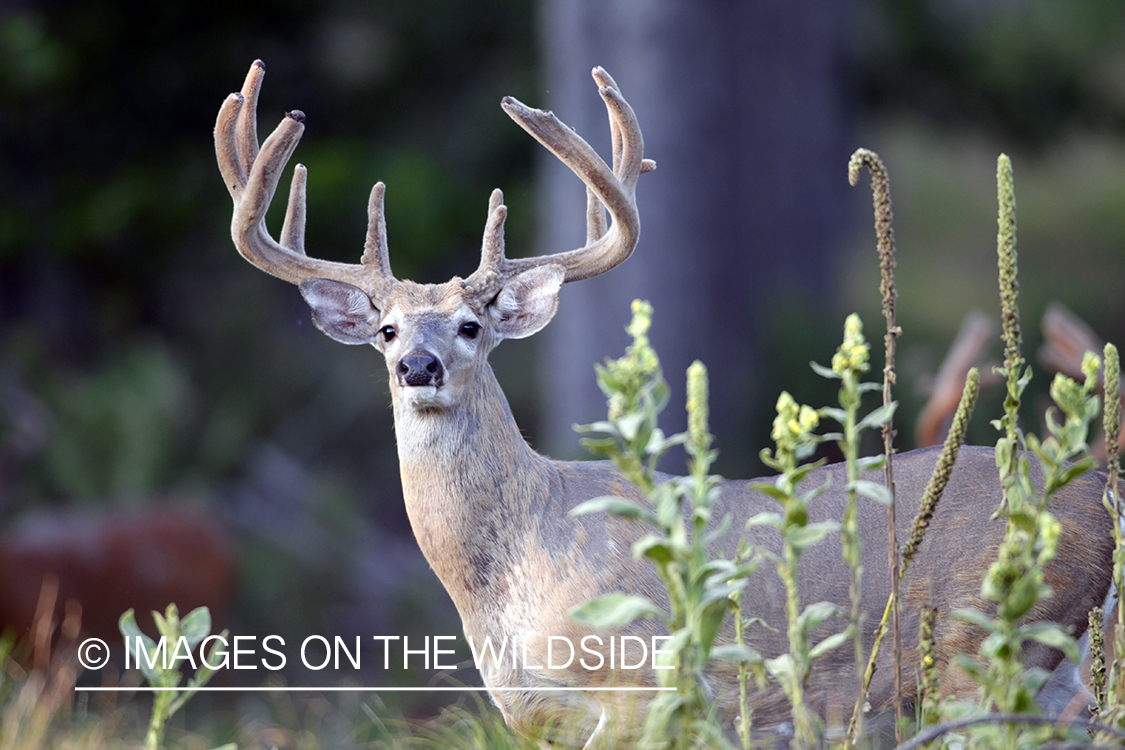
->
xmin=215 ymin=62 xmax=1113 ymax=747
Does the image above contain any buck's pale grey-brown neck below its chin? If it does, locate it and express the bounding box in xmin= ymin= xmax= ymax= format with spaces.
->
xmin=393 ymin=367 xmax=557 ymax=618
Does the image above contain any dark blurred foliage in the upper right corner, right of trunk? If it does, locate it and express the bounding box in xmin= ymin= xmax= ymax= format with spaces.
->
xmin=856 ymin=0 xmax=1125 ymax=150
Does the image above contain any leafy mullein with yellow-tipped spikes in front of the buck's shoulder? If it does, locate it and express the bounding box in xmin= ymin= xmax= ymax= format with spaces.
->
xmin=570 ymin=301 xmax=764 ymax=748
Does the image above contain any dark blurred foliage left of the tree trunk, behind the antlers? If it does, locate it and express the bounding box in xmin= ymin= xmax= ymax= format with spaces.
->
xmin=0 ymin=0 xmax=534 ymax=510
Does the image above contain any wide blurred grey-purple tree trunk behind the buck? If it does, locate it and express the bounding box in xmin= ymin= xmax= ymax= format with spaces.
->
xmin=539 ymin=0 xmax=855 ymax=472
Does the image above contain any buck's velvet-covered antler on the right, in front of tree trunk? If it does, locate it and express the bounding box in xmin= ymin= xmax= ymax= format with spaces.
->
xmin=466 ymin=67 xmax=655 ymax=289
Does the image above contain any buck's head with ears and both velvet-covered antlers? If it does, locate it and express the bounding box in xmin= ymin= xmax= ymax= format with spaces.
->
xmin=215 ymin=61 xmax=655 ymax=410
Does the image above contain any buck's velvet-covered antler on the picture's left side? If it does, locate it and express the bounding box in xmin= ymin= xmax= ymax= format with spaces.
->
xmin=215 ymin=61 xmax=396 ymax=298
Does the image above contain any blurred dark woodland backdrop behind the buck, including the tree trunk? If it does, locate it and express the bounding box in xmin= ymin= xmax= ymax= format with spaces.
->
xmin=0 ymin=0 xmax=1125 ymax=733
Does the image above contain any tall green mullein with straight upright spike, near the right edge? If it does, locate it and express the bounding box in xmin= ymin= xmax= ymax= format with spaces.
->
xmin=953 ymin=154 xmax=1100 ymax=748
